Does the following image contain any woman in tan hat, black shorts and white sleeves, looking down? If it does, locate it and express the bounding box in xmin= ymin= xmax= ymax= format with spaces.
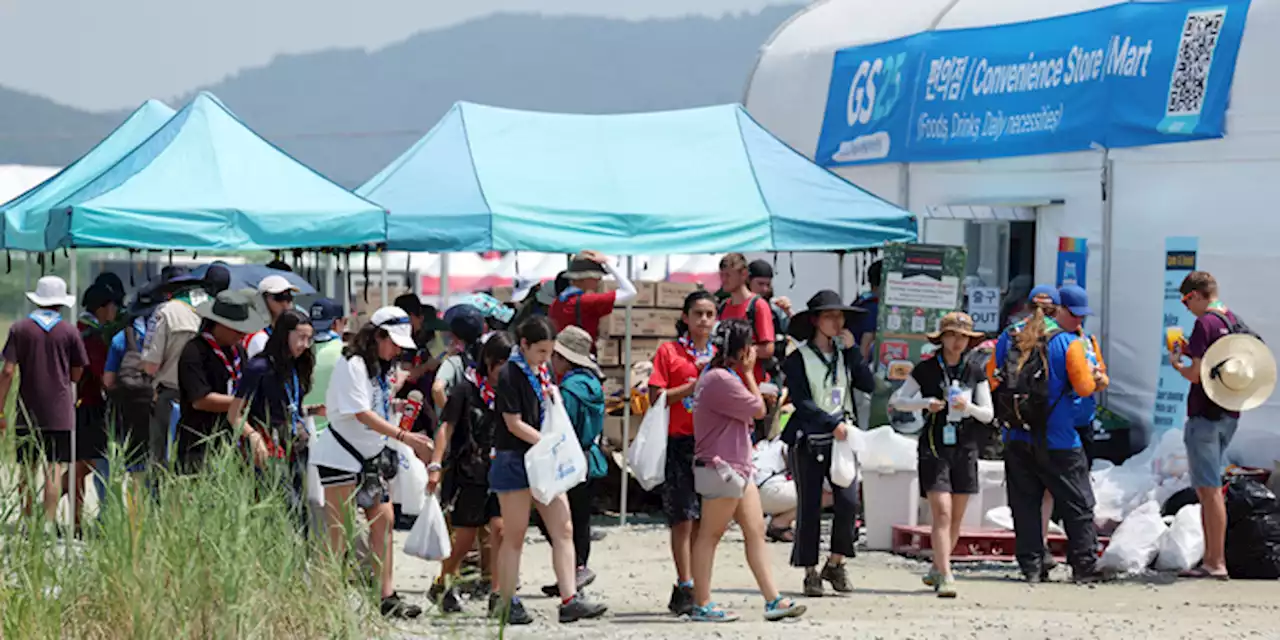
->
xmin=890 ymin=311 xmax=995 ymax=598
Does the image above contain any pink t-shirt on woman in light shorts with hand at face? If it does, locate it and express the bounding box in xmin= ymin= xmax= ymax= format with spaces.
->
xmin=694 ymin=367 xmax=764 ymax=477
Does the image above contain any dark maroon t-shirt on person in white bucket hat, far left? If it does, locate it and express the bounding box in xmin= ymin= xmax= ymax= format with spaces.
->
xmin=4 ymin=317 xmax=88 ymax=431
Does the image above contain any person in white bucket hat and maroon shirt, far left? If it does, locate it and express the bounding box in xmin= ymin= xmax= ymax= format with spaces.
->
xmin=0 ymin=275 xmax=88 ymax=527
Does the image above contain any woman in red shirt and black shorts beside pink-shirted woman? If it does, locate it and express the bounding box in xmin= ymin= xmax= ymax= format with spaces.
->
xmin=649 ymin=291 xmax=716 ymax=616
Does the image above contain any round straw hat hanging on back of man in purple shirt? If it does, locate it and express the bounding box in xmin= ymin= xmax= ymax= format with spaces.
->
xmin=1201 ymin=333 xmax=1276 ymax=411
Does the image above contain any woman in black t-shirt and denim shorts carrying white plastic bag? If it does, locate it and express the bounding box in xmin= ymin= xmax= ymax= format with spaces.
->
xmin=489 ymin=316 xmax=607 ymax=625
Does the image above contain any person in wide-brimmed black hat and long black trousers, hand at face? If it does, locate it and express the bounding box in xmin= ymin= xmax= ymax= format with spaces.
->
xmin=782 ymin=291 xmax=876 ymax=598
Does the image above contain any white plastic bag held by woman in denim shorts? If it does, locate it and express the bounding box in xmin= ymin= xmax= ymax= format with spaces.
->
xmin=525 ymin=388 xmax=586 ymax=504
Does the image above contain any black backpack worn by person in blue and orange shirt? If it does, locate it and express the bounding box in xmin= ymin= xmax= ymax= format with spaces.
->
xmin=992 ymin=329 xmax=1066 ymax=444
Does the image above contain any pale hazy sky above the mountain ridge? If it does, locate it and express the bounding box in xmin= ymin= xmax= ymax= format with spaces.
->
xmin=0 ymin=0 xmax=797 ymax=110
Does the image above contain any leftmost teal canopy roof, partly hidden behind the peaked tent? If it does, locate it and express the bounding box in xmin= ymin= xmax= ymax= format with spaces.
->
xmin=0 ymin=100 xmax=174 ymax=251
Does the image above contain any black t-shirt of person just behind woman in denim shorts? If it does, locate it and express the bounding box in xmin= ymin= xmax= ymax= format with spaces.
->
xmin=443 ymin=380 xmax=496 ymax=486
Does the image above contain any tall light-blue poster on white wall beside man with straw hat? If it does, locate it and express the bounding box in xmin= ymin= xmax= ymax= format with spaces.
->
xmin=1151 ymin=237 xmax=1199 ymax=442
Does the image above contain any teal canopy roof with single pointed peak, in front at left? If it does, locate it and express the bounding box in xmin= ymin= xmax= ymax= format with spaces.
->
xmin=46 ymin=93 xmax=387 ymax=251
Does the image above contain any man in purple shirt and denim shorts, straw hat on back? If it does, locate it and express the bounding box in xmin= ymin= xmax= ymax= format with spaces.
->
xmin=1169 ymin=271 xmax=1276 ymax=580
